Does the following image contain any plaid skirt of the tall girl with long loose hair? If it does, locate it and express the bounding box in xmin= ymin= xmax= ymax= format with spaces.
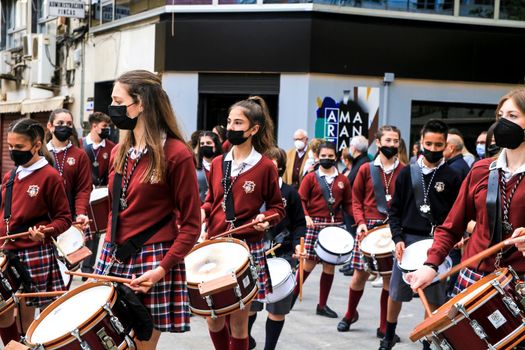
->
xmin=95 ymin=242 xmax=190 ymax=333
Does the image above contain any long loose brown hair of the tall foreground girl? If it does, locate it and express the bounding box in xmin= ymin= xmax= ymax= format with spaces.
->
xmin=113 ymin=70 xmax=184 ymax=182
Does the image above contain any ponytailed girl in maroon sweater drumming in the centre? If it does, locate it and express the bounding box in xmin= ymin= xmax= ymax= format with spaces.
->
xmin=202 ymin=96 xmax=284 ymax=350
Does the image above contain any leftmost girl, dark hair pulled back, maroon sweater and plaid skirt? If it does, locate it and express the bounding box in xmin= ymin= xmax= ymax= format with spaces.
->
xmin=0 ymin=118 xmax=71 ymax=345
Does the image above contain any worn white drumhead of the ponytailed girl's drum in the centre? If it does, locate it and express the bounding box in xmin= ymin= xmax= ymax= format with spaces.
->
xmin=184 ymin=241 xmax=250 ymax=283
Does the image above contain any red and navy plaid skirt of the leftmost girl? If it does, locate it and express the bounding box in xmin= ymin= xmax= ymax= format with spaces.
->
xmin=13 ymin=243 xmax=67 ymax=307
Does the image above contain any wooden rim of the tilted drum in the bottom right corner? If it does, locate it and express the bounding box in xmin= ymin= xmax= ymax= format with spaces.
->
xmin=409 ymin=267 xmax=513 ymax=341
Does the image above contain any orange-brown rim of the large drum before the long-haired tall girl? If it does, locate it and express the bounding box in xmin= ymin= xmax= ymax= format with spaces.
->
xmin=26 ymin=282 xmax=117 ymax=346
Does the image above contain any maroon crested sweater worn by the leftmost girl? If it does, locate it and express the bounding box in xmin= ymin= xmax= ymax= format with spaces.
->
xmin=0 ymin=165 xmax=71 ymax=249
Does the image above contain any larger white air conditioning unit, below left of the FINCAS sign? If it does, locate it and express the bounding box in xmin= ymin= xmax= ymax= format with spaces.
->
xmin=31 ymin=34 xmax=56 ymax=85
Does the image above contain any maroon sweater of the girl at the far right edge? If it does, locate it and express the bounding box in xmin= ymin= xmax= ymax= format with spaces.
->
xmin=427 ymin=159 xmax=525 ymax=274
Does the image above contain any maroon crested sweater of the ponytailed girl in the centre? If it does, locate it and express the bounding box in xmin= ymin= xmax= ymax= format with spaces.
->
xmin=202 ymin=156 xmax=285 ymax=242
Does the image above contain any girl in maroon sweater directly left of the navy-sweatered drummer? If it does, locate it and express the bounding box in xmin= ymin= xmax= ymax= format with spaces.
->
xmin=337 ymin=125 xmax=404 ymax=344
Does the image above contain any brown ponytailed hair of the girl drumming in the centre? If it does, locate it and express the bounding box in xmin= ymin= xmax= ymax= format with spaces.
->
xmin=229 ymin=96 xmax=275 ymax=154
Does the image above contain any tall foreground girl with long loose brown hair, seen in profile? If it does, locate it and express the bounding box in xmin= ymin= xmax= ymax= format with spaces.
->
xmin=96 ymin=70 xmax=200 ymax=349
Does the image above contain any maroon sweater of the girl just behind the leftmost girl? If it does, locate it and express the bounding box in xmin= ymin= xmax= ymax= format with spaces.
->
xmin=51 ymin=146 xmax=93 ymax=215
